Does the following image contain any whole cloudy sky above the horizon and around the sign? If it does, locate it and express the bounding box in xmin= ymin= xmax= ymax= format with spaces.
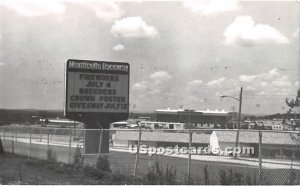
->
xmin=0 ymin=0 xmax=300 ymax=114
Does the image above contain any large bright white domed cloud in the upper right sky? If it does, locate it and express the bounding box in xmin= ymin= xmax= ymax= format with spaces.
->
xmin=224 ymin=16 xmax=289 ymax=46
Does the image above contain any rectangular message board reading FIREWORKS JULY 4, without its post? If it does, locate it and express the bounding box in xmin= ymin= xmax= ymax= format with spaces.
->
xmin=65 ymin=59 xmax=130 ymax=117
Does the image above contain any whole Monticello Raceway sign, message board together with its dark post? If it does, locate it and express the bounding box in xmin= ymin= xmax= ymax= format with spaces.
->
xmin=65 ymin=59 xmax=130 ymax=154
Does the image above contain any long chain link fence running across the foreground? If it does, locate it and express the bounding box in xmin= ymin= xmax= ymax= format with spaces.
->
xmin=0 ymin=126 xmax=300 ymax=185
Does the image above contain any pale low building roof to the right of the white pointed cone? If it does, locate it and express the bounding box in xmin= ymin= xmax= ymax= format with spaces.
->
xmin=215 ymin=131 xmax=299 ymax=145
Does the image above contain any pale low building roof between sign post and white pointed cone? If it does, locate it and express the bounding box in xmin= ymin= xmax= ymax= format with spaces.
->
xmin=114 ymin=131 xmax=210 ymax=144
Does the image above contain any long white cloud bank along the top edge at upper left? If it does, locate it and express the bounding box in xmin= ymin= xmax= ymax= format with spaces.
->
xmin=0 ymin=0 xmax=124 ymax=21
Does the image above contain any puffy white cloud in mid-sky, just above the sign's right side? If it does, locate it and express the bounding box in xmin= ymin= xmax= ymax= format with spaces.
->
xmin=111 ymin=17 xmax=158 ymax=38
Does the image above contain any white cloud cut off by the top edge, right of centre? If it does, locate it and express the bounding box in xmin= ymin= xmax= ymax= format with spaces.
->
xmin=182 ymin=0 xmax=240 ymax=15
